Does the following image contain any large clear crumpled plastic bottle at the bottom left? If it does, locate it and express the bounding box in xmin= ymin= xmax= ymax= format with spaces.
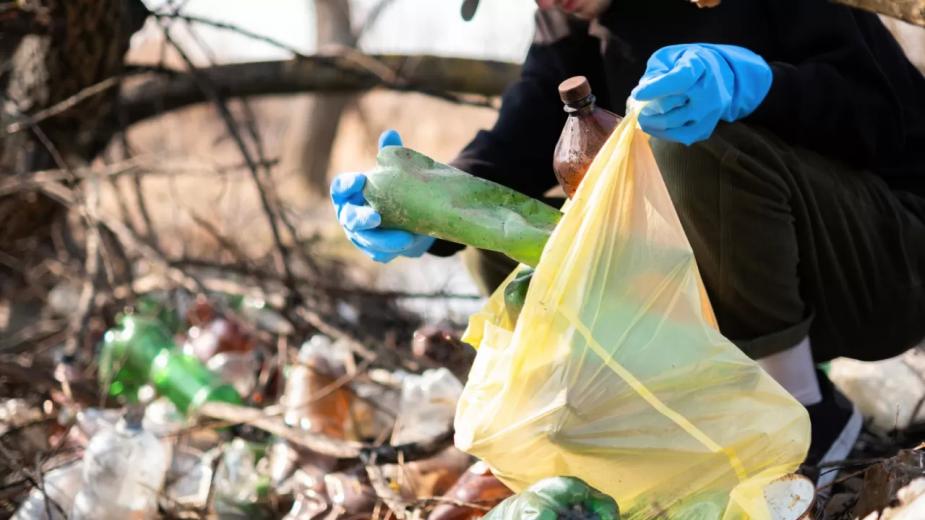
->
xmin=70 ymin=413 xmax=168 ymax=520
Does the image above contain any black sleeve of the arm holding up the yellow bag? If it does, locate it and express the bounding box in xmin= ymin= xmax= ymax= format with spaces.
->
xmin=747 ymin=0 xmax=911 ymax=168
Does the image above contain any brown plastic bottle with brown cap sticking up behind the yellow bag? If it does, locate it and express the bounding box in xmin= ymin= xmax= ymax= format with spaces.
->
xmin=552 ymin=76 xmax=623 ymax=198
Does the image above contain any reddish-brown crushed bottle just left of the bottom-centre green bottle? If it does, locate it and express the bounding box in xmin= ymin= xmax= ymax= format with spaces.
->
xmin=427 ymin=461 xmax=514 ymax=520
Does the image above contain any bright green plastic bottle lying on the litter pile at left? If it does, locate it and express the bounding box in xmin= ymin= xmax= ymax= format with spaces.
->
xmin=99 ymin=315 xmax=242 ymax=413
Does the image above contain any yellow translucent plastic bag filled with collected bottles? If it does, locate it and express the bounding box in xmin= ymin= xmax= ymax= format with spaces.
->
xmin=455 ymin=108 xmax=809 ymax=520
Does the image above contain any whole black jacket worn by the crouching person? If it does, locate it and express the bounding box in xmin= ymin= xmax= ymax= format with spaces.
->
xmin=432 ymin=0 xmax=925 ymax=254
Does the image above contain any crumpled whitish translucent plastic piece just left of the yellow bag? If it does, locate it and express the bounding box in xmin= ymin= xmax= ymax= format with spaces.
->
xmin=392 ymin=368 xmax=463 ymax=444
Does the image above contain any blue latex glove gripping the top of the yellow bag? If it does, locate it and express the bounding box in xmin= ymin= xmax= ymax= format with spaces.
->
xmin=632 ymin=43 xmax=774 ymax=145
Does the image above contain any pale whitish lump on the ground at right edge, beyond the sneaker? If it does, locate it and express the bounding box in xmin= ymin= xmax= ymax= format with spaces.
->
xmin=829 ymin=349 xmax=925 ymax=433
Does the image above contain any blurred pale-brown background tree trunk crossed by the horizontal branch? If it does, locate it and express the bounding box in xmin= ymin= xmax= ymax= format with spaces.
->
xmin=282 ymin=0 xmax=356 ymax=196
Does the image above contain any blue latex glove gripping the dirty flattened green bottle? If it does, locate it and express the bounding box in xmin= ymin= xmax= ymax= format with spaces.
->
xmin=331 ymin=130 xmax=434 ymax=263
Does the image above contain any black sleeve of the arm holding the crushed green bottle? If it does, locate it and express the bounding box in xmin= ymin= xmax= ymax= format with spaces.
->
xmin=429 ymin=11 xmax=606 ymax=256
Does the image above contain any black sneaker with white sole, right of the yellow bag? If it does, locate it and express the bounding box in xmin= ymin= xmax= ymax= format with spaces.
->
xmin=802 ymin=371 xmax=863 ymax=488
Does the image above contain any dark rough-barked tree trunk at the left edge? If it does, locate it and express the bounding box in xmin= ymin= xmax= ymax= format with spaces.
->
xmin=0 ymin=0 xmax=147 ymax=280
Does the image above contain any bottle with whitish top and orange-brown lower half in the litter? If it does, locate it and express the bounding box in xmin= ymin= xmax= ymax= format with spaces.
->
xmin=280 ymin=335 xmax=351 ymax=439
